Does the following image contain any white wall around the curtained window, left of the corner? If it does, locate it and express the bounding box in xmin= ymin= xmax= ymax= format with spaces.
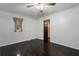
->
xmin=0 ymin=11 xmax=36 ymax=46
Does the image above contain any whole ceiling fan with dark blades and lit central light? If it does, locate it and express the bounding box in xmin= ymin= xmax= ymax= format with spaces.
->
xmin=26 ymin=3 xmax=56 ymax=12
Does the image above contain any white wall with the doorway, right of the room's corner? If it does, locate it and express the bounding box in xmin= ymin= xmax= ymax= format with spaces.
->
xmin=37 ymin=6 xmax=79 ymax=49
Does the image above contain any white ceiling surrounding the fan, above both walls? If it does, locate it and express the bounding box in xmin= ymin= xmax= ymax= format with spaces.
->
xmin=0 ymin=3 xmax=79 ymax=18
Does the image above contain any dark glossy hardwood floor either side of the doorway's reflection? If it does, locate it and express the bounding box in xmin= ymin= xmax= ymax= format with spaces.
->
xmin=0 ymin=39 xmax=79 ymax=56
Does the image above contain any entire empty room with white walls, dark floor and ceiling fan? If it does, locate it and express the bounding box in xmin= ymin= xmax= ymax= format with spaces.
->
xmin=0 ymin=3 xmax=79 ymax=56
